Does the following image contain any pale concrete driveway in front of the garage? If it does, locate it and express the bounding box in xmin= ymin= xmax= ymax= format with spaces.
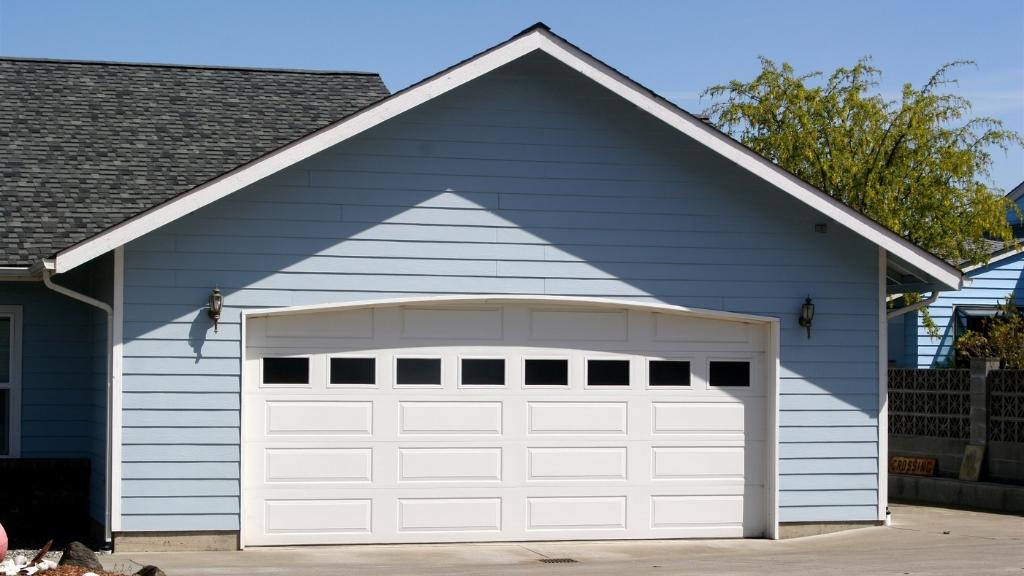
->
xmin=102 ymin=505 xmax=1024 ymax=576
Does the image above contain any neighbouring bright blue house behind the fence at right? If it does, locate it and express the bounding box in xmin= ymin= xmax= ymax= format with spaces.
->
xmin=889 ymin=182 xmax=1024 ymax=368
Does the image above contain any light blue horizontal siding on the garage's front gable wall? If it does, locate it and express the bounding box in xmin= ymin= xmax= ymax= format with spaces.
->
xmin=124 ymin=51 xmax=880 ymax=530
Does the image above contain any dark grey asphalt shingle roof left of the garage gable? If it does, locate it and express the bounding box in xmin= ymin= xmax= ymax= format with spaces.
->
xmin=0 ymin=58 xmax=388 ymax=266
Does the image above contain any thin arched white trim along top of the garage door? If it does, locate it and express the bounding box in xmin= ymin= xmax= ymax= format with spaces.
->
xmin=242 ymin=294 xmax=778 ymax=324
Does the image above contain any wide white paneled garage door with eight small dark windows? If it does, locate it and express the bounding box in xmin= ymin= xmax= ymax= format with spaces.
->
xmin=243 ymin=300 xmax=768 ymax=545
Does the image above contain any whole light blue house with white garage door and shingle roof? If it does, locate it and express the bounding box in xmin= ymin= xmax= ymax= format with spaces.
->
xmin=0 ymin=25 xmax=962 ymax=549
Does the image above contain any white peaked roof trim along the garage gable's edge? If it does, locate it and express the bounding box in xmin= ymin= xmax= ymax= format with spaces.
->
xmin=48 ymin=26 xmax=961 ymax=289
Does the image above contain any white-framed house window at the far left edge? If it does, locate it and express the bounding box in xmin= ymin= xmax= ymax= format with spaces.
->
xmin=0 ymin=306 xmax=22 ymax=458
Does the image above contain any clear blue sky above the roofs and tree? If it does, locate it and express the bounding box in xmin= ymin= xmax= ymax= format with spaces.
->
xmin=0 ymin=0 xmax=1024 ymax=190
